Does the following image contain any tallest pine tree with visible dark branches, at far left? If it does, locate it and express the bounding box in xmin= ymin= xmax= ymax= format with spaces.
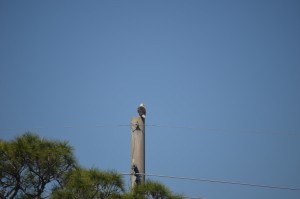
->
xmin=0 ymin=133 xmax=76 ymax=199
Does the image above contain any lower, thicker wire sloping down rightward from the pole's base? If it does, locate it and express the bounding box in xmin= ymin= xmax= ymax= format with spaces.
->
xmin=120 ymin=173 xmax=300 ymax=191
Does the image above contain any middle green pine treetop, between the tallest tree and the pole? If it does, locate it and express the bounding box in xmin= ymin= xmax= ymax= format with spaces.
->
xmin=51 ymin=168 xmax=124 ymax=199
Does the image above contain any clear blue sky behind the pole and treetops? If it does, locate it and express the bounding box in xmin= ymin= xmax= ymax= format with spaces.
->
xmin=0 ymin=0 xmax=300 ymax=199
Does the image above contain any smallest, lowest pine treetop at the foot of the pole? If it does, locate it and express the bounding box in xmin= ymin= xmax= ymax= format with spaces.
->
xmin=125 ymin=180 xmax=183 ymax=199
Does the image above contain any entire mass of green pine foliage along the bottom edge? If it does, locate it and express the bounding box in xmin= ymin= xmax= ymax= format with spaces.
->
xmin=0 ymin=133 xmax=183 ymax=199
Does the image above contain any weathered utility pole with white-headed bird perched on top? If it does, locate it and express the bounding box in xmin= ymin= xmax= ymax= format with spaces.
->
xmin=130 ymin=104 xmax=146 ymax=188
